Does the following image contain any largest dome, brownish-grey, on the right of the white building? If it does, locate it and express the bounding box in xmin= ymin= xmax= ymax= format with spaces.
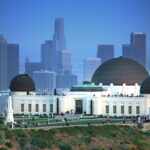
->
xmin=92 ymin=57 xmax=149 ymax=85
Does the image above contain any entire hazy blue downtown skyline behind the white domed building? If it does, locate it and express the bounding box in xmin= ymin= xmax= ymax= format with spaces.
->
xmin=0 ymin=18 xmax=147 ymax=93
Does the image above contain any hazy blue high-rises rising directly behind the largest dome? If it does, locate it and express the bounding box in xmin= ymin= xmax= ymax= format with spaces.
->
xmin=83 ymin=32 xmax=147 ymax=81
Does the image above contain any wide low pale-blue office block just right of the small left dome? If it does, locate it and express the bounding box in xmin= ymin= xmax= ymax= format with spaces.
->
xmin=33 ymin=70 xmax=56 ymax=93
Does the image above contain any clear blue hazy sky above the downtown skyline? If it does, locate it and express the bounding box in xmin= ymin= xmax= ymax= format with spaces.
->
xmin=0 ymin=0 xmax=150 ymax=79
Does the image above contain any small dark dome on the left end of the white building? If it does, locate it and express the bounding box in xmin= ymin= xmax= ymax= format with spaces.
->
xmin=10 ymin=74 xmax=35 ymax=92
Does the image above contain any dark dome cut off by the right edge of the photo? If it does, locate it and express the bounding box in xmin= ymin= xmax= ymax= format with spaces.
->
xmin=140 ymin=77 xmax=150 ymax=94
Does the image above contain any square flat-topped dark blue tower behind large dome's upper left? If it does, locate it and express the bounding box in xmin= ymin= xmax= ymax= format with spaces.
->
xmin=97 ymin=44 xmax=114 ymax=63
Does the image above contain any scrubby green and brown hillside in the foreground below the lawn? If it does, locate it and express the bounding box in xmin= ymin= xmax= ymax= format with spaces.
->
xmin=0 ymin=125 xmax=150 ymax=150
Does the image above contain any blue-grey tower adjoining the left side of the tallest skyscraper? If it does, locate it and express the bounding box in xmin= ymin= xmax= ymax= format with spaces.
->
xmin=41 ymin=40 xmax=57 ymax=71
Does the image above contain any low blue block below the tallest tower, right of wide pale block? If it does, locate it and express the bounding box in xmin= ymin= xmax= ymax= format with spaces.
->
xmin=56 ymin=73 xmax=77 ymax=89
